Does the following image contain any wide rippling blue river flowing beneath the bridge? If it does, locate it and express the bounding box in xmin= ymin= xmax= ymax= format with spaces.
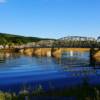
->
xmin=0 ymin=52 xmax=100 ymax=92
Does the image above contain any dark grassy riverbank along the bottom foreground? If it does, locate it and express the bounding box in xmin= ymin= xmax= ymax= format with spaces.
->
xmin=0 ymin=83 xmax=100 ymax=100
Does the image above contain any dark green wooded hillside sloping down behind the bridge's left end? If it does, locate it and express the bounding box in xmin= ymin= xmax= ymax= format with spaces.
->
xmin=0 ymin=33 xmax=52 ymax=45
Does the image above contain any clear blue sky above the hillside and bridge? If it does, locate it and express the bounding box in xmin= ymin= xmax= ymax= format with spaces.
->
xmin=0 ymin=0 xmax=100 ymax=38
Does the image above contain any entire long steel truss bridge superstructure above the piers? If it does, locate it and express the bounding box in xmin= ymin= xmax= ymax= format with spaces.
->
xmin=15 ymin=36 xmax=100 ymax=49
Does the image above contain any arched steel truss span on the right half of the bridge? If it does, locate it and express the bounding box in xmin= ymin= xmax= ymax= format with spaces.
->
xmin=52 ymin=36 xmax=100 ymax=48
